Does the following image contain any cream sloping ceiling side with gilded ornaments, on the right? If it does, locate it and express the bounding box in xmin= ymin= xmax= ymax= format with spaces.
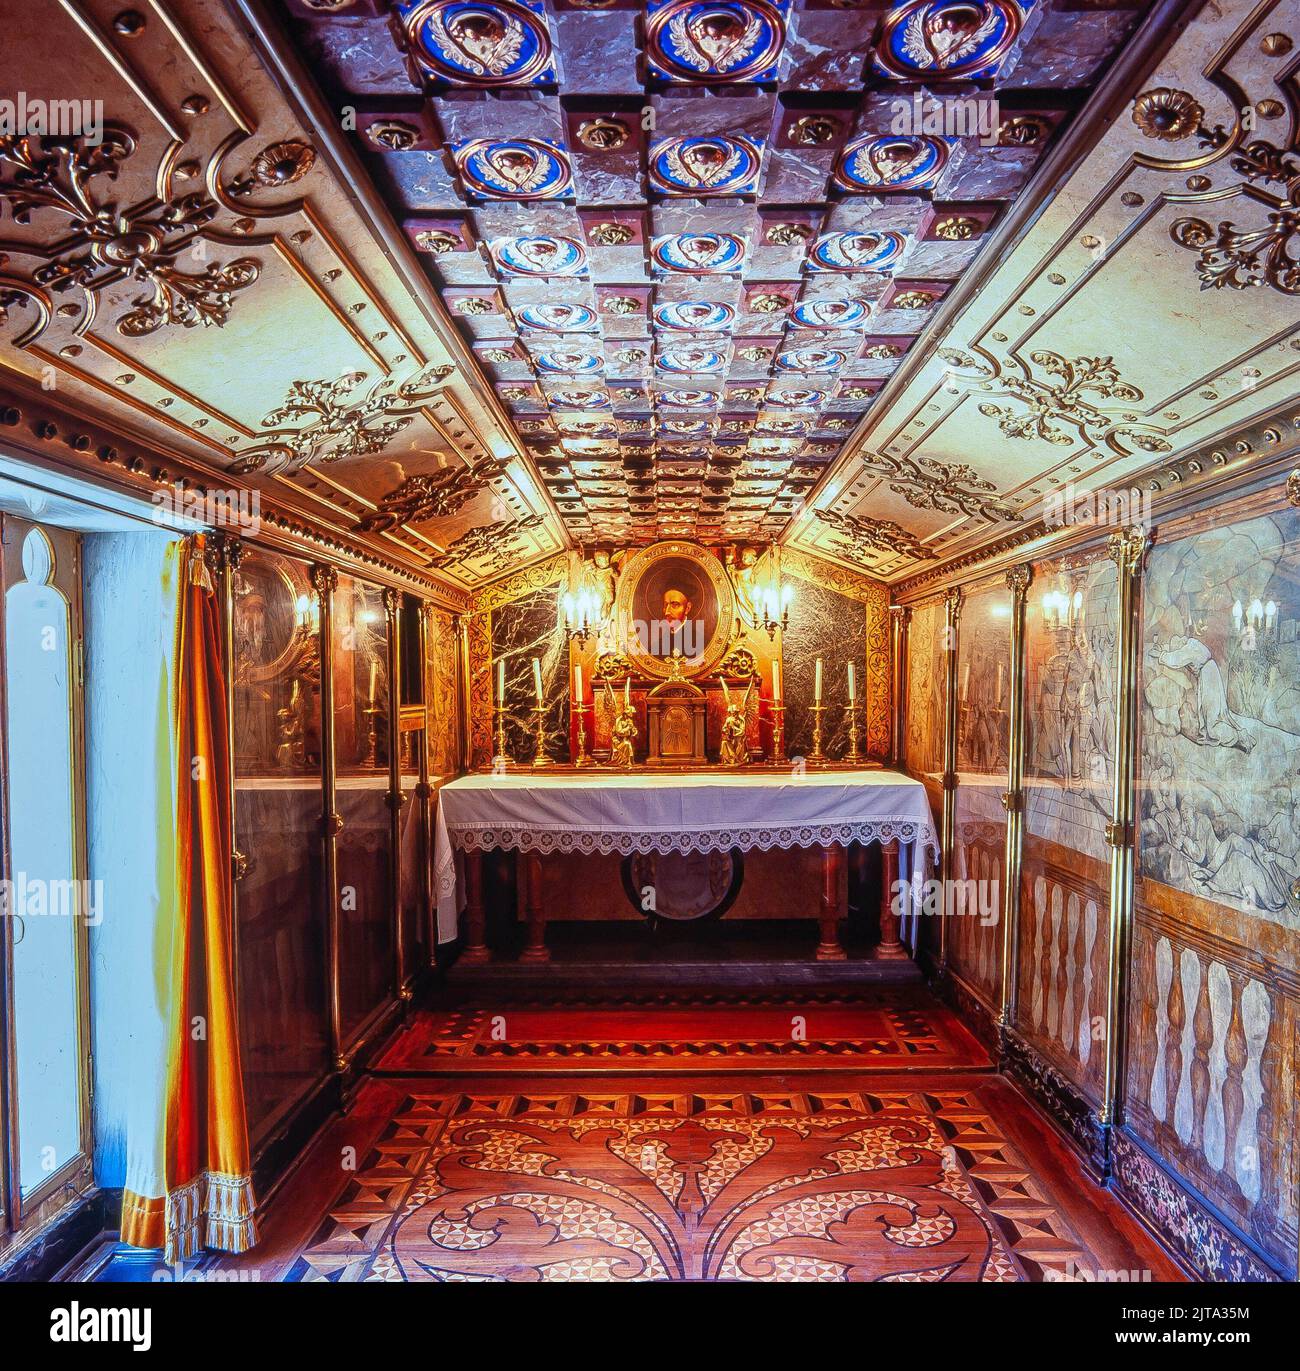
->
xmin=787 ymin=0 xmax=1300 ymax=579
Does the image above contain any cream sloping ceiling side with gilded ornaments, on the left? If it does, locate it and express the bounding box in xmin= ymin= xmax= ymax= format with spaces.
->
xmin=0 ymin=0 xmax=565 ymax=585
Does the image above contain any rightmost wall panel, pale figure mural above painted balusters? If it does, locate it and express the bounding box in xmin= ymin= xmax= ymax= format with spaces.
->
xmin=1126 ymin=492 xmax=1300 ymax=1272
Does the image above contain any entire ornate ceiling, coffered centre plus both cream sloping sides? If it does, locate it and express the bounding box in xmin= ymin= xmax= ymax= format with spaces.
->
xmin=0 ymin=0 xmax=1300 ymax=591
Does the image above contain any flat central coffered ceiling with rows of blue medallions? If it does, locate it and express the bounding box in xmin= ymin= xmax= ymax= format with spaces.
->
xmin=279 ymin=0 xmax=1142 ymax=559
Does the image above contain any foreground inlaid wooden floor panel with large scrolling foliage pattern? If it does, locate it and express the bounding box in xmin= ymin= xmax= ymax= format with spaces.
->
xmin=285 ymin=1076 xmax=1087 ymax=1282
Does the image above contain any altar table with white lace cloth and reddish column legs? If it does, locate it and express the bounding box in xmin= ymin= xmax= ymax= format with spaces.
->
xmin=435 ymin=766 xmax=938 ymax=965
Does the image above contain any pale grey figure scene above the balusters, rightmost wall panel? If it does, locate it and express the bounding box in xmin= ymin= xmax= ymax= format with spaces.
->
xmin=1141 ymin=510 xmax=1300 ymax=928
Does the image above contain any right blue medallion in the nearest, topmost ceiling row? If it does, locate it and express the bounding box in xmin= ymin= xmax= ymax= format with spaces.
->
xmin=875 ymin=0 xmax=1033 ymax=81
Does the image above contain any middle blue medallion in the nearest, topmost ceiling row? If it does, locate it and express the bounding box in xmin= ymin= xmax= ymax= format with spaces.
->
xmin=646 ymin=0 xmax=790 ymax=85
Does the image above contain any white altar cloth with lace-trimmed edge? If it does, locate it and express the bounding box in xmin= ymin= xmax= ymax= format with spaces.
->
xmin=433 ymin=771 xmax=939 ymax=942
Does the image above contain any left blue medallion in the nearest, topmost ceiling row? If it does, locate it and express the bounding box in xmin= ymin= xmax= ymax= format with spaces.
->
xmin=398 ymin=0 xmax=555 ymax=86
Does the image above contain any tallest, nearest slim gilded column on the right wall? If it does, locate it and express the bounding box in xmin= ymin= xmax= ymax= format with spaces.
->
xmin=1098 ymin=526 xmax=1149 ymax=1124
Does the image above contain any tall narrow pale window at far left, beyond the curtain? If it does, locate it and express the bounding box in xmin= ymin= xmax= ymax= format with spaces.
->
xmin=0 ymin=515 xmax=92 ymax=1246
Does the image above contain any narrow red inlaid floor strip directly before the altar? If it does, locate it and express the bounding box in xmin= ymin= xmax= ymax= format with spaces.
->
xmin=380 ymin=988 xmax=990 ymax=1075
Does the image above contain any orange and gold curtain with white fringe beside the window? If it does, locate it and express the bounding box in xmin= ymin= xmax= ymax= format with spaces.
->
xmin=122 ymin=535 xmax=256 ymax=1261
